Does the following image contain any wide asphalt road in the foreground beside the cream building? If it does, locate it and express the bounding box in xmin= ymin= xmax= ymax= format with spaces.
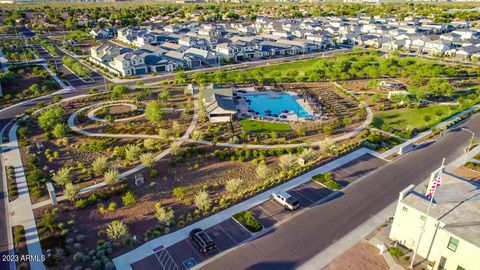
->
xmin=201 ymin=115 xmax=480 ymax=270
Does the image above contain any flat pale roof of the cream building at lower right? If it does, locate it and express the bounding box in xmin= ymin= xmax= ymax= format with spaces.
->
xmin=401 ymin=173 xmax=480 ymax=247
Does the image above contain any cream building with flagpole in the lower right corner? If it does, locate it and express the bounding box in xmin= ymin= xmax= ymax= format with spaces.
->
xmin=390 ymin=173 xmax=480 ymax=270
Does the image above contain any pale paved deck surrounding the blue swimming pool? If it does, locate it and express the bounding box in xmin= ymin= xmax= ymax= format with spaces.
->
xmin=236 ymin=88 xmax=318 ymax=122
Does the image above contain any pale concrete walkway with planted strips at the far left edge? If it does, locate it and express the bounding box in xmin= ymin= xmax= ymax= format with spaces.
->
xmin=2 ymin=124 xmax=45 ymax=270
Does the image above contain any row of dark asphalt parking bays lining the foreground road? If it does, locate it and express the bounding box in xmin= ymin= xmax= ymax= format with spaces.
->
xmin=132 ymin=154 xmax=386 ymax=270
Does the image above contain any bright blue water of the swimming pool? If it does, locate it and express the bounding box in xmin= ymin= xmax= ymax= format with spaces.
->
xmin=245 ymin=94 xmax=311 ymax=118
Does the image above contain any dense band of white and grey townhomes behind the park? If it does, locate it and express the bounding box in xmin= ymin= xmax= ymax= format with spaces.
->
xmin=90 ymin=15 xmax=480 ymax=76
